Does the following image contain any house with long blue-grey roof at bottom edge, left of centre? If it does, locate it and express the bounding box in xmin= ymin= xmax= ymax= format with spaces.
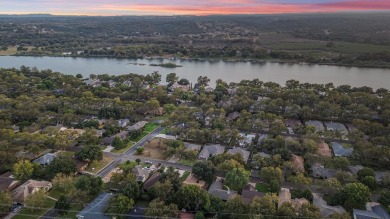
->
xmin=76 ymin=192 xmax=113 ymax=219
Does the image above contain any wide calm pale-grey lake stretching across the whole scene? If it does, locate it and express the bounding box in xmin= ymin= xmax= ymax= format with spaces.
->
xmin=0 ymin=56 xmax=390 ymax=89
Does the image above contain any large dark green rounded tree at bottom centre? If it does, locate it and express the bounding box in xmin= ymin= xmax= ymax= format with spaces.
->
xmin=174 ymin=185 xmax=210 ymax=211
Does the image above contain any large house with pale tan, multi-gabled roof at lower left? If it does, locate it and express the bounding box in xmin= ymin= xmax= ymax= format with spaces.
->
xmin=11 ymin=179 xmax=52 ymax=204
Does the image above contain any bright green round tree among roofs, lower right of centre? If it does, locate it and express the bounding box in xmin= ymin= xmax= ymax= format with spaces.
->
xmin=225 ymin=168 xmax=250 ymax=191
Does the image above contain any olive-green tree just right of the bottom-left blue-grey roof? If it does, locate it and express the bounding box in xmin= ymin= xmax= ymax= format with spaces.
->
xmin=105 ymin=194 xmax=134 ymax=218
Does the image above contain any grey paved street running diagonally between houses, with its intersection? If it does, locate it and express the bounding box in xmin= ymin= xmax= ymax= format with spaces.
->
xmin=96 ymin=126 xmax=164 ymax=178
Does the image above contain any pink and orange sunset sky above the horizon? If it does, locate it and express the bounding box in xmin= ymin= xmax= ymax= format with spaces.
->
xmin=0 ymin=0 xmax=390 ymax=15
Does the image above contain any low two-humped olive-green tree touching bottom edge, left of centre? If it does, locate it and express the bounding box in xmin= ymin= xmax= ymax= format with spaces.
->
xmin=145 ymin=198 xmax=179 ymax=218
